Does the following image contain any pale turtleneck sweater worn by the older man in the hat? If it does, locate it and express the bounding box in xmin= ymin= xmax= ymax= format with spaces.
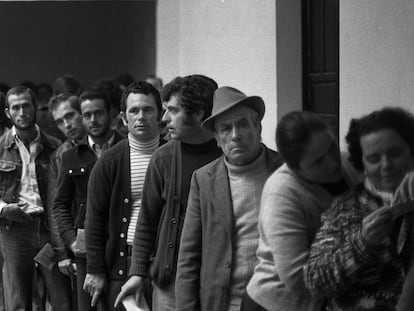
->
xmin=225 ymin=150 xmax=267 ymax=310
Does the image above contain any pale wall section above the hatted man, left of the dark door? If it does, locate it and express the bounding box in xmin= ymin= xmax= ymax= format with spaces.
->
xmin=156 ymin=0 xmax=277 ymax=148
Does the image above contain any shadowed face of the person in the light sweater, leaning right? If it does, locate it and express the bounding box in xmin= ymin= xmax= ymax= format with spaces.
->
xmin=297 ymin=130 xmax=342 ymax=184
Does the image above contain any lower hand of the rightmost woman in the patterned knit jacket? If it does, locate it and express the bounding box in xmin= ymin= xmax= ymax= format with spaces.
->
xmin=361 ymin=206 xmax=394 ymax=247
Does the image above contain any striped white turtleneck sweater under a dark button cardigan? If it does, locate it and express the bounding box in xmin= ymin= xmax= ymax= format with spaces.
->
xmin=127 ymin=134 xmax=160 ymax=245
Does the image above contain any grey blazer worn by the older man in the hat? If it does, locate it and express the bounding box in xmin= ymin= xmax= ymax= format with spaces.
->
xmin=175 ymin=148 xmax=283 ymax=311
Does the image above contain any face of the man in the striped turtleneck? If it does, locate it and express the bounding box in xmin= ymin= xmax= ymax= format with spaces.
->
xmin=121 ymin=93 xmax=159 ymax=141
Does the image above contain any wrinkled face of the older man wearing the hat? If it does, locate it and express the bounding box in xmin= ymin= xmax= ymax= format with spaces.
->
xmin=214 ymin=106 xmax=261 ymax=166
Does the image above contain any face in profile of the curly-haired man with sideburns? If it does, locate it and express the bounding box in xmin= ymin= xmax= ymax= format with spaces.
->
xmin=162 ymin=96 xmax=201 ymax=142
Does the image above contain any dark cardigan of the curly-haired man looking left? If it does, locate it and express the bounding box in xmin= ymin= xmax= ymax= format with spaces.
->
xmin=129 ymin=140 xmax=221 ymax=288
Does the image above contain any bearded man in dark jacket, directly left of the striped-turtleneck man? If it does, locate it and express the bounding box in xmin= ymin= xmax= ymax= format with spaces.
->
xmin=53 ymin=91 xmax=122 ymax=311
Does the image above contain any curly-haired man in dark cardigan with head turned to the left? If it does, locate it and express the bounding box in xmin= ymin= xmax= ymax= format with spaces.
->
xmin=115 ymin=75 xmax=222 ymax=311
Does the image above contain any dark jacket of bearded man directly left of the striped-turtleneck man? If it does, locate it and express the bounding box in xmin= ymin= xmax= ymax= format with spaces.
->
xmin=53 ymin=132 xmax=122 ymax=248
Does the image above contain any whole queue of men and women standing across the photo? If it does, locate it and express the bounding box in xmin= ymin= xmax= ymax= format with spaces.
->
xmin=0 ymin=75 xmax=414 ymax=311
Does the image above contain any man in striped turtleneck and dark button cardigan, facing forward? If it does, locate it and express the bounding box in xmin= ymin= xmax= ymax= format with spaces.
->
xmin=84 ymin=82 xmax=161 ymax=310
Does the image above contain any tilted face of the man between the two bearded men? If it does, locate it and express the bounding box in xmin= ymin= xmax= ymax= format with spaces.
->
xmin=52 ymin=101 xmax=85 ymax=140
